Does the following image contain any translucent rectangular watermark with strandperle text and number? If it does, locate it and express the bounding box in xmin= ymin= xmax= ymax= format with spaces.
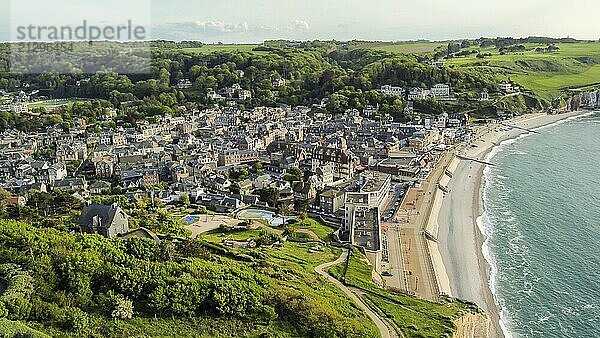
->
xmin=8 ymin=0 xmax=151 ymax=74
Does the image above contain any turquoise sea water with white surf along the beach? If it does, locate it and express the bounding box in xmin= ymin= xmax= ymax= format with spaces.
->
xmin=478 ymin=113 xmax=600 ymax=338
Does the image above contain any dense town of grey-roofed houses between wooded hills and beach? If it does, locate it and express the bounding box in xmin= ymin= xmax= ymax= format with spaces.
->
xmin=0 ymin=81 xmax=488 ymax=271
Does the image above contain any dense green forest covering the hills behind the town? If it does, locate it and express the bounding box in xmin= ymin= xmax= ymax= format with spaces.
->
xmin=0 ymin=41 xmax=524 ymax=131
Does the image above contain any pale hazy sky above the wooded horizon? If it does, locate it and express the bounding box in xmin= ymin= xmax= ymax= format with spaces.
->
xmin=0 ymin=0 xmax=600 ymax=43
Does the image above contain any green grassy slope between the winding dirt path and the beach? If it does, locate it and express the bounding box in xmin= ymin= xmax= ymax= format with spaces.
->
xmin=329 ymin=250 xmax=477 ymax=337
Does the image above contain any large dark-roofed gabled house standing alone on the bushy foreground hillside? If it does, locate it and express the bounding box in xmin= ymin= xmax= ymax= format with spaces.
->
xmin=77 ymin=204 xmax=129 ymax=238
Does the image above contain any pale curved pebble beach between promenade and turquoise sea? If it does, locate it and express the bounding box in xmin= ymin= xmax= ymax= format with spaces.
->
xmin=428 ymin=111 xmax=585 ymax=338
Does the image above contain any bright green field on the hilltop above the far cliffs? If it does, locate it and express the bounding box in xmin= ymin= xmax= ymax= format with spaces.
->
xmin=448 ymin=42 xmax=600 ymax=100
